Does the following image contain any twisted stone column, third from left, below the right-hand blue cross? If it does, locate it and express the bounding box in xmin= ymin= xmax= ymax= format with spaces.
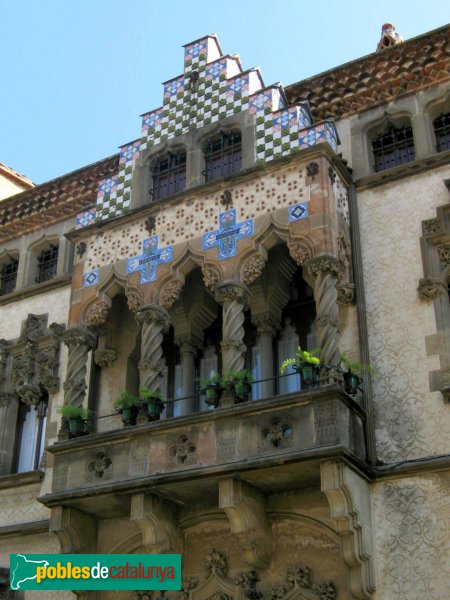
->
xmin=216 ymin=283 xmax=250 ymax=375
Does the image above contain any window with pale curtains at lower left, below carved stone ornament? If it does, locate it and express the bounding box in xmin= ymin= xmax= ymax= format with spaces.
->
xmin=16 ymin=398 xmax=47 ymax=473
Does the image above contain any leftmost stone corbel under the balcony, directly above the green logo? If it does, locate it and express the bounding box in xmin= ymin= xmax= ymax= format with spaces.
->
xmin=50 ymin=506 xmax=97 ymax=554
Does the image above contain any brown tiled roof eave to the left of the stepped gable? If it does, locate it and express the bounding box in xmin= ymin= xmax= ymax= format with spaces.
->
xmin=0 ymin=154 xmax=119 ymax=242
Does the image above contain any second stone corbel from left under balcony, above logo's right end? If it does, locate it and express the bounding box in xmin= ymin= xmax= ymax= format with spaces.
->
xmin=130 ymin=494 xmax=181 ymax=554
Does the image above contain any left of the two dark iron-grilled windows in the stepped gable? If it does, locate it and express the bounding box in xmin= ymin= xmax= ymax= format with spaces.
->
xmin=150 ymin=152 xmax=186 ymax=201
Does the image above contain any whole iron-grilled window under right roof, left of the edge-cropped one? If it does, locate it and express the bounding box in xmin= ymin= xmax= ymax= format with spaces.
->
xmin=372 ymin=125 xmax=416 ymax=173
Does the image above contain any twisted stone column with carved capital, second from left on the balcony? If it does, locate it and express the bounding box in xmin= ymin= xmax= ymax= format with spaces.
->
xmin=136 ymin=304 xmax=170 ymax=391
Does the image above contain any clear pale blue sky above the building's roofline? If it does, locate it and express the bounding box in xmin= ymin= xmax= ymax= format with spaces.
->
xmin=0 ymin=0 xmax=450 ymax=183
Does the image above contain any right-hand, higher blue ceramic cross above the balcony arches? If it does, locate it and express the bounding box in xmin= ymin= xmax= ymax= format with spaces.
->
xmin=203 ymin=208 xmax=253 ymax=260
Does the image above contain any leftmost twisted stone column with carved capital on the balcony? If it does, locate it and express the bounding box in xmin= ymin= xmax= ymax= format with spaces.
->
xmin=62 ymin=325 xmax=97 ymax=407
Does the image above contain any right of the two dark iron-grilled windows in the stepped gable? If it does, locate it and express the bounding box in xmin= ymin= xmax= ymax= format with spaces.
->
xmin=203 ymin=131 xmax=242 ymax=181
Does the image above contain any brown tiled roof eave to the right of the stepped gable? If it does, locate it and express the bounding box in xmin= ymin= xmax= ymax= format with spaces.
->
xmin=285 ymin=25 xmax=450 ymax=119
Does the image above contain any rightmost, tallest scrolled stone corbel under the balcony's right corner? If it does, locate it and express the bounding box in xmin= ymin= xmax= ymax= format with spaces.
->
xmin=320 ymin=461 xmax=375 ymax=599
